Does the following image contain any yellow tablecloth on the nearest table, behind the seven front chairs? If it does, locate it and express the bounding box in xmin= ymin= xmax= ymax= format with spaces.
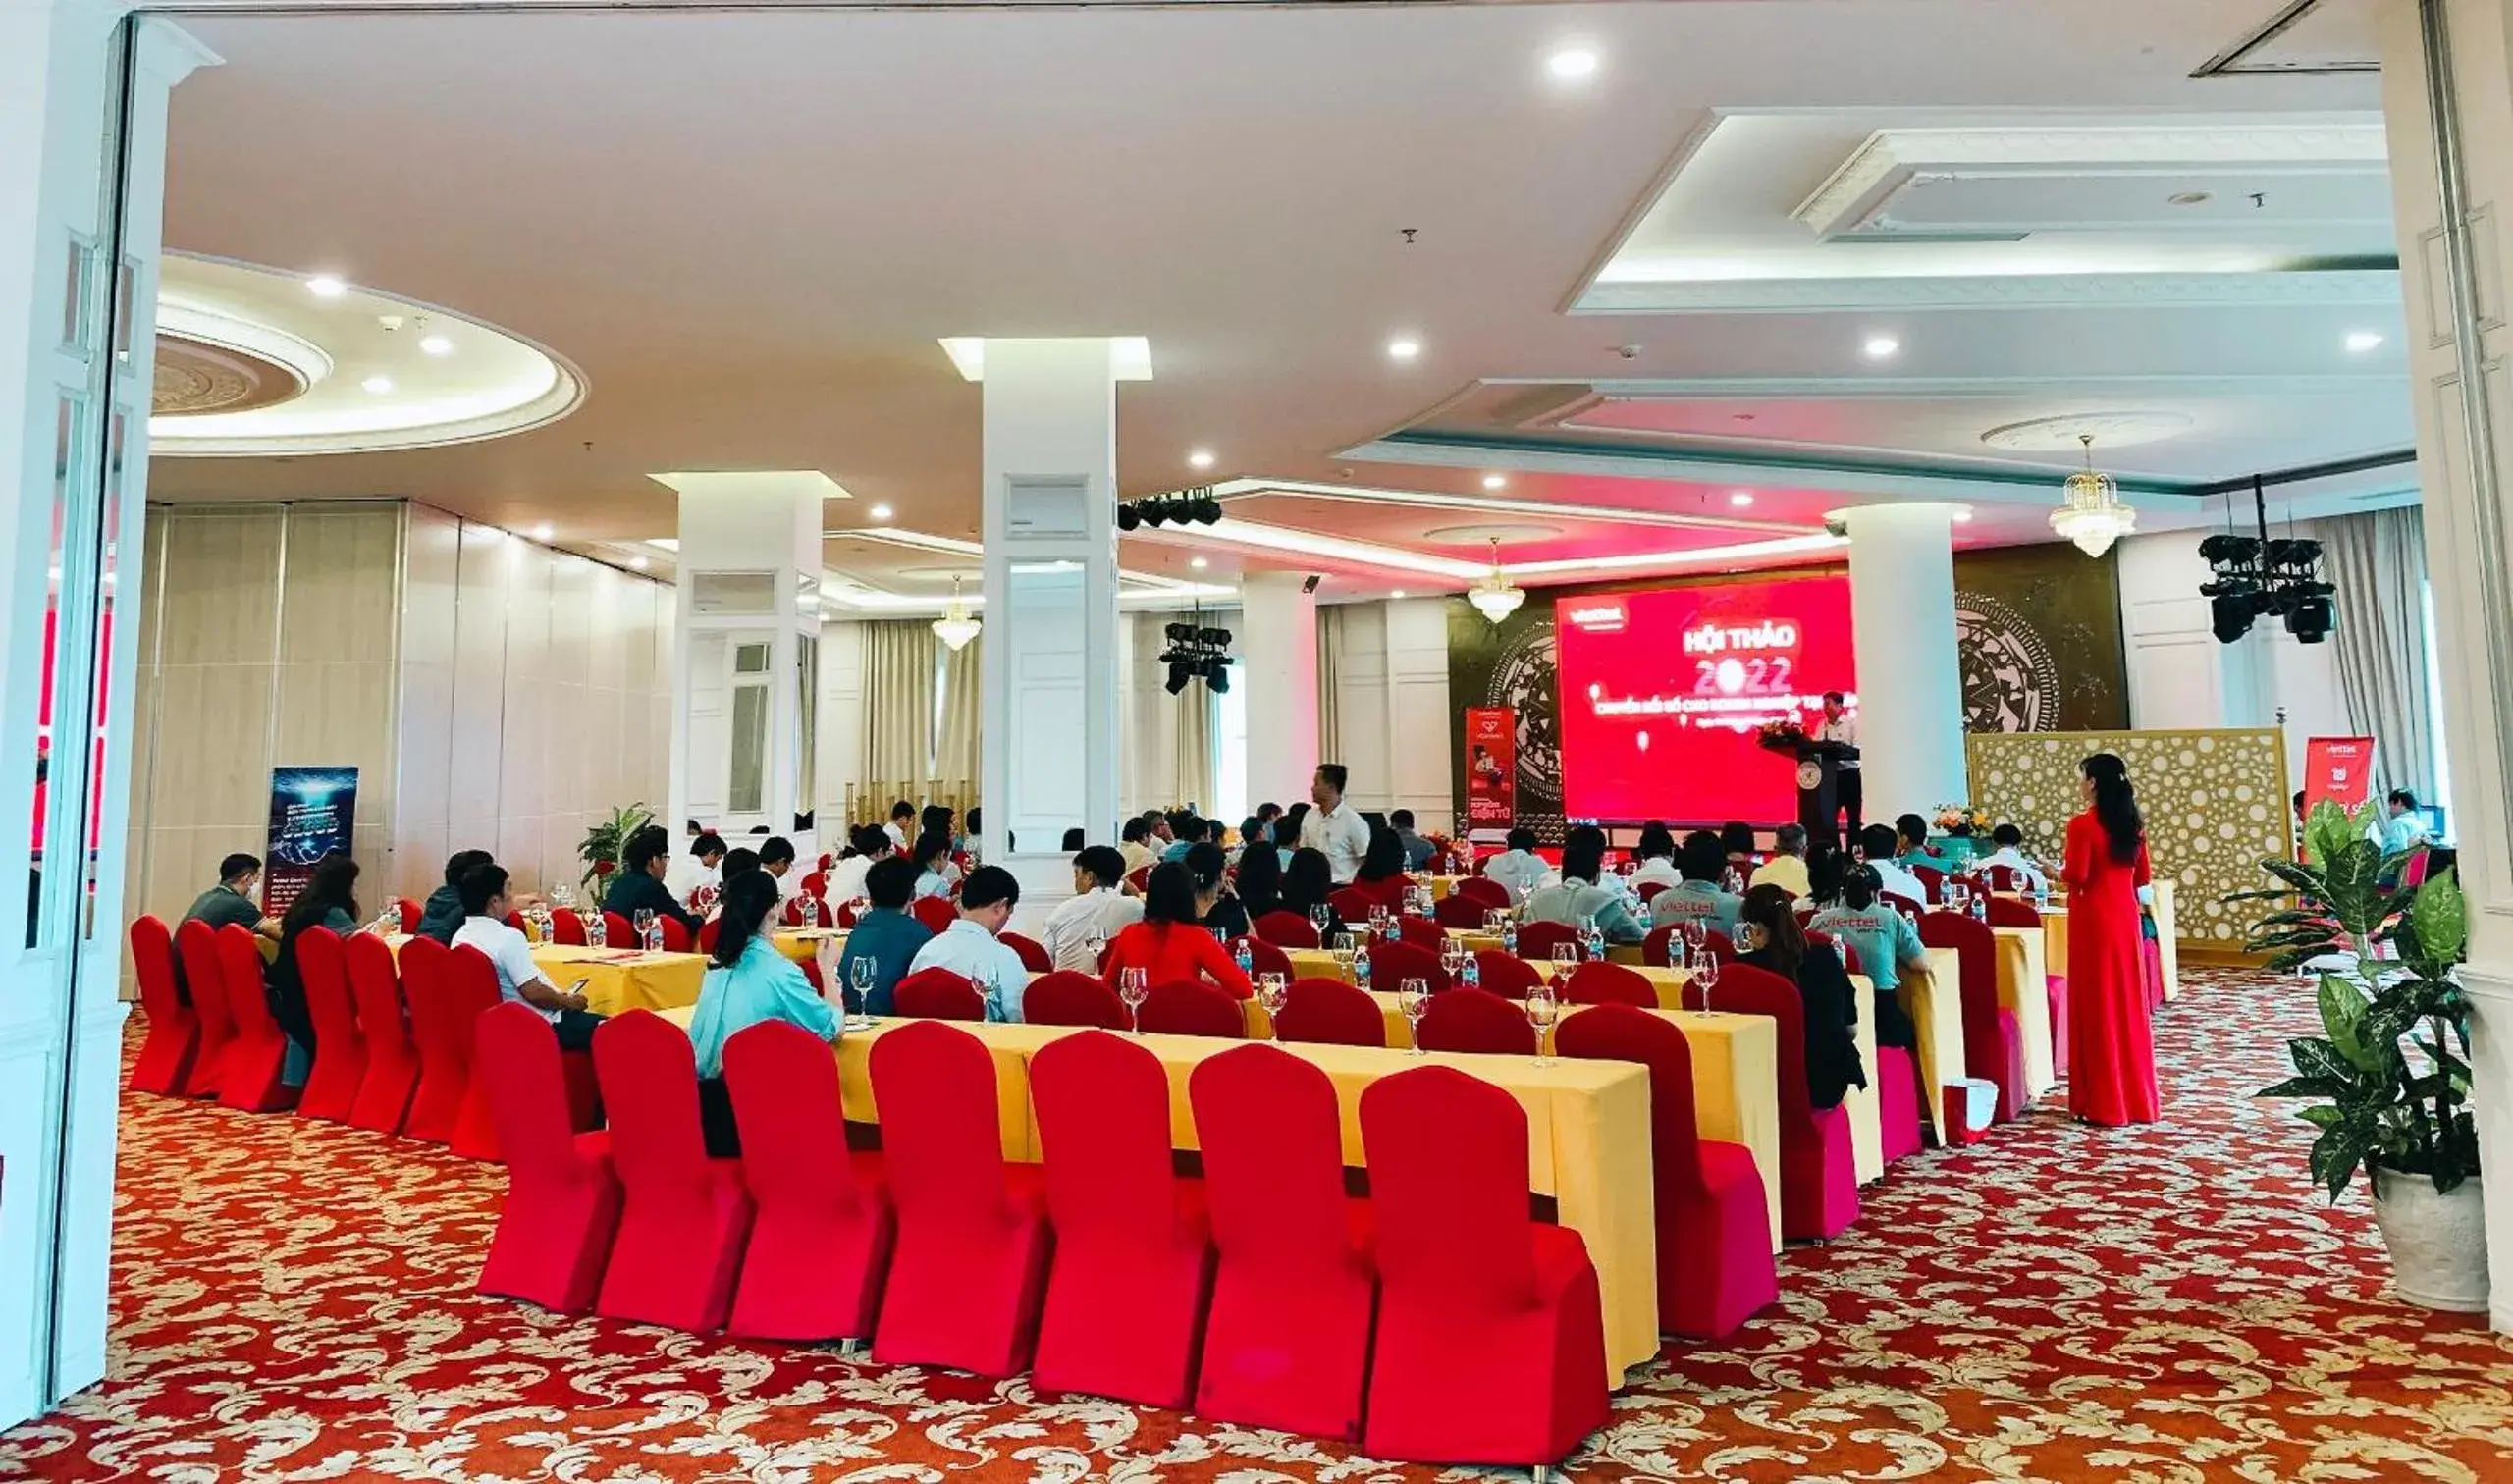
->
xmin=668 ymin=1009 xmax=1659 ymax=1373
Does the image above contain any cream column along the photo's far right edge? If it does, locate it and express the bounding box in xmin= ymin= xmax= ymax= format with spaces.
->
xmin=2339 ymin=0 xmax=2513 ymax=1333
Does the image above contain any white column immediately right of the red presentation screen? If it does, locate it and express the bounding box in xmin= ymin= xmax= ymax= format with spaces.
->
xmin=1847 ymin=504 xmax=1965 ymax=823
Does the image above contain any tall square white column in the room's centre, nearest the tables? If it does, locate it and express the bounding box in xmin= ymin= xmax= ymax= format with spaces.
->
xmin=978 ymin=339 xmax=1121 ymax=924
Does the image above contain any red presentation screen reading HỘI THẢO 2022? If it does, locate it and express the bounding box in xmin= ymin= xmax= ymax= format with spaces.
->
xmin=1553 ymin=577 xmax=1857 ymax=823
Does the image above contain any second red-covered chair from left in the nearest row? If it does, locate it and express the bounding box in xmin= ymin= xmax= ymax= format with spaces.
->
xmin=593 ymin=1009 xmax=748 ymax=1333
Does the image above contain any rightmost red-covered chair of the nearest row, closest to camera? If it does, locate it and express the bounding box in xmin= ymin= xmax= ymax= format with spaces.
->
xmin=1363 ymin=1069 xmax=1608 ymax=1466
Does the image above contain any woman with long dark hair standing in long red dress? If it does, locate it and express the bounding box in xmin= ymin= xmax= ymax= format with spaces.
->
xmin=2060 ymin=754 xmax=2162 ymax=1125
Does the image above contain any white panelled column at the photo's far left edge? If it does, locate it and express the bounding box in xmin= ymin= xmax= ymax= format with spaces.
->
xmin=0 ymin=0 xmax=216 ymax=1429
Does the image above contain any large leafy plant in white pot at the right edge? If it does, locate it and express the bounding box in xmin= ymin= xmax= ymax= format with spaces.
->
xmin=2236 ymin=801 xmax=2487 ymax=1313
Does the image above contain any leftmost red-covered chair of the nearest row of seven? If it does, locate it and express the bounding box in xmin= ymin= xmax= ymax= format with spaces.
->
xmin=474 ymin=999 xmax=622 ymax=1313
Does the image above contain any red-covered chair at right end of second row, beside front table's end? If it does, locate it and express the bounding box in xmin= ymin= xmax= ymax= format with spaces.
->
xmin=1553 ymin=1004 xmax=1779 ymax=1341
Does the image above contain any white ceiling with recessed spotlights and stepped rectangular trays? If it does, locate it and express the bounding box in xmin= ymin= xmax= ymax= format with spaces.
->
xmin=151 ymin=0 xmax=2410 ymax=598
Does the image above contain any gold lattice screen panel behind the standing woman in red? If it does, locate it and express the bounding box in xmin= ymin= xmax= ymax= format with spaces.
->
xmin=1965 ymin=728 xmax=2294 ymax=947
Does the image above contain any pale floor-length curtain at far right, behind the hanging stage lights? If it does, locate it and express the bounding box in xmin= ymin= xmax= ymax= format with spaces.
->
xmin=2312 ymin=507 xmax=2435 ymax=804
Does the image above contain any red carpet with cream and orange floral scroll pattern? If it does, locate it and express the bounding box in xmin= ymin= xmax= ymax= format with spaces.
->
xmin=0 ymin=972 xmax=2513 ymax=1484
